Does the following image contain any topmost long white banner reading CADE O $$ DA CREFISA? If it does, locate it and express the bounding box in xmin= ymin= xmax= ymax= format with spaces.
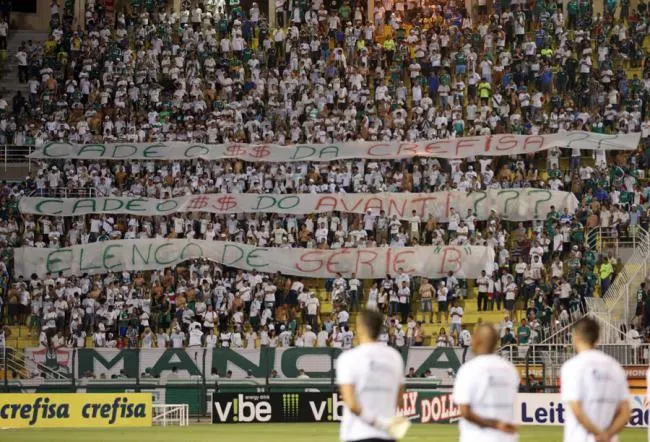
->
xmin=29 ymin=131 xmax=641 ymax=163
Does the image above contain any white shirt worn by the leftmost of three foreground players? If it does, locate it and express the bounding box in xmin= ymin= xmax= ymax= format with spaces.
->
xmin=336 ymin=343 xmax=404 ymax=441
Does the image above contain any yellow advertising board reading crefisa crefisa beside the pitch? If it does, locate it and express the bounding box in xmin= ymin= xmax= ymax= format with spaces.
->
xmin=0 ymin=393 xmax=152 ymax=428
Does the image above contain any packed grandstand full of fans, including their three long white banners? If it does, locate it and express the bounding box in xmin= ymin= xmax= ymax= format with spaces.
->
xmin=0 ymin=0 xmax=650 ymax=380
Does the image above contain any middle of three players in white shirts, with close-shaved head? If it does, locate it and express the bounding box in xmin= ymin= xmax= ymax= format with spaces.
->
xmin=453 ymin=323 xmax=519 ymax=442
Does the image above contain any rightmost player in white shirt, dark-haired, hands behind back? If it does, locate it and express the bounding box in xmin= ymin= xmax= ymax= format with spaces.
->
xmin=560 ymin=317 xmax=630 ymax=442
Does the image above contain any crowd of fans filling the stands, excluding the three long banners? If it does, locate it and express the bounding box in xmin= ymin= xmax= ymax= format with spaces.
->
xmin=0 ymin=0 xmax=650 ymax=356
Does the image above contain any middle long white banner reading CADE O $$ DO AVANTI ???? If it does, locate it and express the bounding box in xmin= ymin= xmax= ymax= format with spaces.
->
xmin=19 ymin=188 xmax=578 ymax=222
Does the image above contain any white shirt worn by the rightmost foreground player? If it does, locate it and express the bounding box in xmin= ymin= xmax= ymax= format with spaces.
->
xmin=561 ymin=350 xmax=629 ymax=442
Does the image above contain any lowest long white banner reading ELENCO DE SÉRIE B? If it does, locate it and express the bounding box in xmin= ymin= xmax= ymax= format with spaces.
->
xmin=14 ymin=239 xmax=494 ymax=279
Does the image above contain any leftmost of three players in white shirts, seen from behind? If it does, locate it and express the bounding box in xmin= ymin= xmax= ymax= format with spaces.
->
xmin=336 ymin=310 xmax=409 ymax=442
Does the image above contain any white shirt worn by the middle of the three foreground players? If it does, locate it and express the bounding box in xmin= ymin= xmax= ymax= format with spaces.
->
xmin=453 ymin=354 xmax=519 ymax=442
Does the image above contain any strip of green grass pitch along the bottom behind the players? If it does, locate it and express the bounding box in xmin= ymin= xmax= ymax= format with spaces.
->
xmin=0 ymin=422 xmax=648 ymax=442
